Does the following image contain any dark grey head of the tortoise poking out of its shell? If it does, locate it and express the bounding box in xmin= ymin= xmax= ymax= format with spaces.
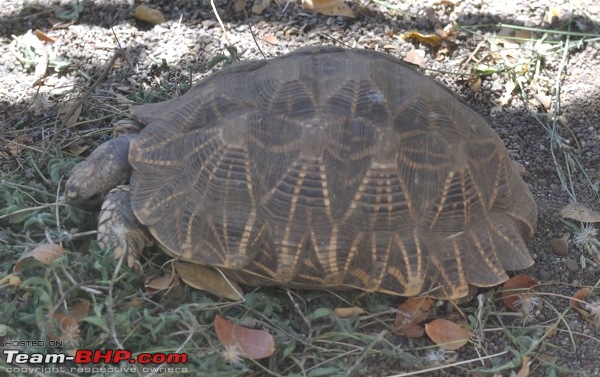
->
xmin=65 ymin=135 xmax=135 ymax=210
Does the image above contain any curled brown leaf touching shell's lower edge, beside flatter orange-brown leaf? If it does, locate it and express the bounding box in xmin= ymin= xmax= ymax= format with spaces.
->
xmin=393 ymin=297 xmax=434 ymax=338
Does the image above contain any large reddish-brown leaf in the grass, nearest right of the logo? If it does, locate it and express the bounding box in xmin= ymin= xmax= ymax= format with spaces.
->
xmin=215 ymin=315 xmax=275 ymax=360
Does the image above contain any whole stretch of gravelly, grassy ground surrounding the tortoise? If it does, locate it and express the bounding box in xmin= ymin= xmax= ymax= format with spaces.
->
xmin=0 ymin=0 xmax=600 ymax=376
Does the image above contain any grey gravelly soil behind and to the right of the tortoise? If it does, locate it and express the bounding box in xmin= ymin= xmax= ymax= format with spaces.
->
xmin=0 ymin=0 xmax=600 ymax=376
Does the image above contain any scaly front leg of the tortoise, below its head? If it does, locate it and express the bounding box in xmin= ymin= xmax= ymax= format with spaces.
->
xmin=98 ymin=185 xmax=152 ymax=269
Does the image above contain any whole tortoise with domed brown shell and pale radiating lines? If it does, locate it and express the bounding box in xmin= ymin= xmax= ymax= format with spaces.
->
xmin=66 ymin=47 xmax=537 ymax=299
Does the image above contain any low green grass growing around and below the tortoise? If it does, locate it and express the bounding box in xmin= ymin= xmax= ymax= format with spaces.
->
xmin=0 ymin=2 xmax=600 ymax=377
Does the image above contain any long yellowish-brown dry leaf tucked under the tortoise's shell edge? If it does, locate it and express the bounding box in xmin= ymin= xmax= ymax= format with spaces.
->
xmin=173 ymin=262 xmax=243 ymax=301
